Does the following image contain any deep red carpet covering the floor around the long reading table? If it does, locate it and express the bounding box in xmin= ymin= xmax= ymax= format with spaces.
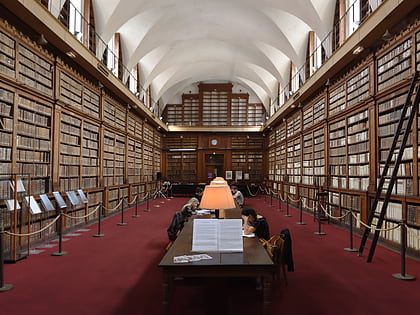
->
xmin=0 ymin=198 xmax=420 ymax=315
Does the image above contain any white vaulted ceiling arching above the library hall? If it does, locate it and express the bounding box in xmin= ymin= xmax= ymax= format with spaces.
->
xmin=93 ymin=0 xmax=336 ymax=110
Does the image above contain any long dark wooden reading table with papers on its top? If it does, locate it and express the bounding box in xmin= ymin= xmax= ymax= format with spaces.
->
xmin=159 ymin=214 xmax=274 ymax=315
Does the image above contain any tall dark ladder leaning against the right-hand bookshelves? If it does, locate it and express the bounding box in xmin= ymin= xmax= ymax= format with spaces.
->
xmin=358 ymin=71 xmax=420 ymax=262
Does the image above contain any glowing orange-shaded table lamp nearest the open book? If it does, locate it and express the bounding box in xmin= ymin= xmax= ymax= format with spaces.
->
xmin=200 ymin=177 xmax=236 ymax=218
